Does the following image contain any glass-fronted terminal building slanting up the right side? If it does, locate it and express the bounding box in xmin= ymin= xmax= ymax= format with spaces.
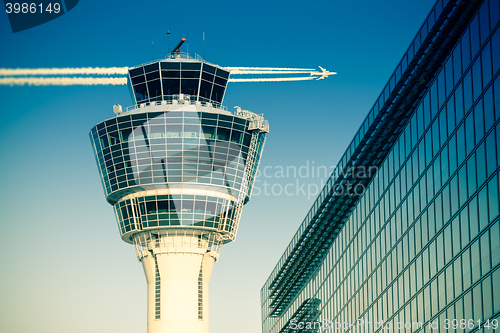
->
xmin=261 ymin=0 xmax=500 ymax=333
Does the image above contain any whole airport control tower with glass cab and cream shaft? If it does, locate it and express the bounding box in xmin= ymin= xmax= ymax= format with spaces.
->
xmin=90 ymin=39 xmax=269 ymax=333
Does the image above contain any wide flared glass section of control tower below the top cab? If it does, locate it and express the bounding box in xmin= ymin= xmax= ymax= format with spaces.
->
xmin=90 ymin=106 xmax=266 ymax=242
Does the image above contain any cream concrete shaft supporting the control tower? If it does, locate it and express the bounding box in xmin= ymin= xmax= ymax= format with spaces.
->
xmin=138 ymin=231 xmax=218 ymax=333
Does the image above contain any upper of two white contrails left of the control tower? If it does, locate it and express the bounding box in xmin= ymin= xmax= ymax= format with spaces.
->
xmin=0 ymin=67 xmax=128 ymax=76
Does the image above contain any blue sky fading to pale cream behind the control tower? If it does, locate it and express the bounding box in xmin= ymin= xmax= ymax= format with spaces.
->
xmin=0 ymin=0 xmax=434 ymax=333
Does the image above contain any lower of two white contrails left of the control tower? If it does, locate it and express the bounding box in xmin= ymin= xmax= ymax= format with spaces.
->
xmin=0 ymin=77 xmax=127 ymax=86
